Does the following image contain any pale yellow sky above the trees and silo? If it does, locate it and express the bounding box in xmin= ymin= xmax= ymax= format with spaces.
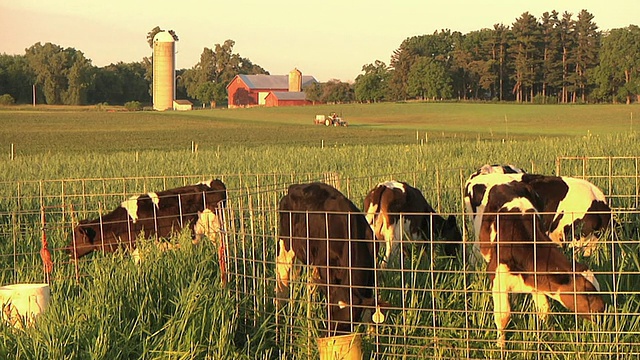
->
xmin=0 ymin=0 xmax=640 ymax=82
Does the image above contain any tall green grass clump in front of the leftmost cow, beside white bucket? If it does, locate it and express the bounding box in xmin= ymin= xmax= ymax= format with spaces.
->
xmin=0 ymin=236 xmax=272 ymax=359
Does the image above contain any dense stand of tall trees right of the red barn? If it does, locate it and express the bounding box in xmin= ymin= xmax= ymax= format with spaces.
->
xmin=354 ymin=10 xmax=640 ymax=103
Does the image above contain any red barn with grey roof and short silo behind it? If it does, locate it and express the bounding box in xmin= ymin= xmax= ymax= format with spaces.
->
xmin=227 ymin=69 xmax=317 ymax=108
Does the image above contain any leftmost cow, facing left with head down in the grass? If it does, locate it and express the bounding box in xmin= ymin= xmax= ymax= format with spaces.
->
xmin=65 ymin=180 xmax=227 ymax=259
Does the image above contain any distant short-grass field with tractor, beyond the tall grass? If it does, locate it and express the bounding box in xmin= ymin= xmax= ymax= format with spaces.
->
xmin=0 ymin=103 xmax=640 ymax=155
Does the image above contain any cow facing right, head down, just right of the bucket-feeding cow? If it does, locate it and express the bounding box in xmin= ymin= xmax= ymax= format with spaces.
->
xmin=364 ymin=181 xmax=462 ymax=268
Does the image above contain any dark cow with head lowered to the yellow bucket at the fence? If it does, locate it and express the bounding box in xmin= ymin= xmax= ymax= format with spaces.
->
xmin=276 ymin=182 xmax=378 ymax=334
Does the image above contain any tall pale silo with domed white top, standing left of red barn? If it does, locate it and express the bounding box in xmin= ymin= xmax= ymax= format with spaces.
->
xmin=153 ymin=31 xmax=176 ymax=111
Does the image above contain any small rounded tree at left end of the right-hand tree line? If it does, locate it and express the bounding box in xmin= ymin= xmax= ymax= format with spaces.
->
xmin=354 ymin=60 xmax=390 ymax=102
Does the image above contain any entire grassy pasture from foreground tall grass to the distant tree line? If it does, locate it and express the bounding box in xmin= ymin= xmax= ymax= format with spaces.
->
xmin=0 ymin=103 xmax=640 ymax=359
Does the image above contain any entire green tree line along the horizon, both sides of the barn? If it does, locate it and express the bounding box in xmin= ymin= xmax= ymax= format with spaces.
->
xmin=0 ymin=10 xmax=640 ymax=105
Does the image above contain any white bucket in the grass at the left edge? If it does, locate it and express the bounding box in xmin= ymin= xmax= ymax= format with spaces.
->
xmin=0 ymin=284 xmax=51 ymax=327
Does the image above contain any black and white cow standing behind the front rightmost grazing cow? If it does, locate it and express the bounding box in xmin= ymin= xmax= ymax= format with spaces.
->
xmin=465 ymin=173 xmax=611 ymax=256
